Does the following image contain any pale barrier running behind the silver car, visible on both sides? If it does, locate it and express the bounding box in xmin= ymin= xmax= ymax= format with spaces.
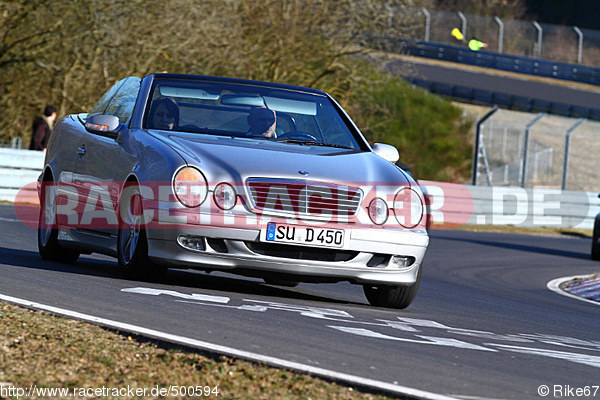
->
xmin=0 ymin=149 xmax=600 ymax=229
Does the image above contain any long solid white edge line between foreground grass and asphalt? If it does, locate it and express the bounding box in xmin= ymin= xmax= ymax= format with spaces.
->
xmin=0 ymin=294 xmax=458 ymax=400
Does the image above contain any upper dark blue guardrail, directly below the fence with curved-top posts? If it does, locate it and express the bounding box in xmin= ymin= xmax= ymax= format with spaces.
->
xmin=400 ymin=38 xmax=600 ymax=85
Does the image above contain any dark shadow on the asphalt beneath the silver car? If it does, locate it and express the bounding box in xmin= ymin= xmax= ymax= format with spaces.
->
xmin=0 ymin=247 xmax=367 ymax=306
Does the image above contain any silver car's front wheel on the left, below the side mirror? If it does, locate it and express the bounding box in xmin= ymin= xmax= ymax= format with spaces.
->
xmin=117 ymin=185 xmax=167 ymax=281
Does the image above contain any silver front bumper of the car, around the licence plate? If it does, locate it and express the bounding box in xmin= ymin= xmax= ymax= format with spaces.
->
xmin=147 ymin=223 xmax=429 ymax=286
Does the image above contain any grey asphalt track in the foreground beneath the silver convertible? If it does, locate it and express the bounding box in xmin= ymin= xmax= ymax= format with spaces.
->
xmin=0 ymin=205 xmax=600 ymax=399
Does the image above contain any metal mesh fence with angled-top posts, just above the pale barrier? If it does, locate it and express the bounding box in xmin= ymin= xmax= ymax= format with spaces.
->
xmin=472 ymin=110 xmax=600 ymax=191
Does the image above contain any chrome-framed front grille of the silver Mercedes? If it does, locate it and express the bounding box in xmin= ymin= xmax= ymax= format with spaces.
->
xmin=246 ymin=178 xmax=362 ymax=216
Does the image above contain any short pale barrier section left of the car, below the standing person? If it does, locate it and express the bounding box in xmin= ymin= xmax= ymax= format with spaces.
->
xmin=0 ymin=148 xmax=44 ymax=203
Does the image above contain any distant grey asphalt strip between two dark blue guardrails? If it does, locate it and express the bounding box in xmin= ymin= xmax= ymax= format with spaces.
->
xmin=385 ymin=59 xmax=600 ymax=109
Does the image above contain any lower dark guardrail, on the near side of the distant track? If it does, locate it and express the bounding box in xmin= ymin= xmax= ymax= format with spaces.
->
xmin=405 ymin=78 xmax=600 ymax=120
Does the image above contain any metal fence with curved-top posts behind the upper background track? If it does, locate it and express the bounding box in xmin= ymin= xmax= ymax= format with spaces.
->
xmin=398 ymin=8 xmax=600 ymax=66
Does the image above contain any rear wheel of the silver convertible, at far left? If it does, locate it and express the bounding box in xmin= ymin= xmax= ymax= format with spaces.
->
xmin=37 ymin=177 xmax=79 ymax=264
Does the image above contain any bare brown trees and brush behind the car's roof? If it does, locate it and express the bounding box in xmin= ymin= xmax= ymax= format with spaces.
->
xmin=0 ymin=0 xmax=424 ymax=144
